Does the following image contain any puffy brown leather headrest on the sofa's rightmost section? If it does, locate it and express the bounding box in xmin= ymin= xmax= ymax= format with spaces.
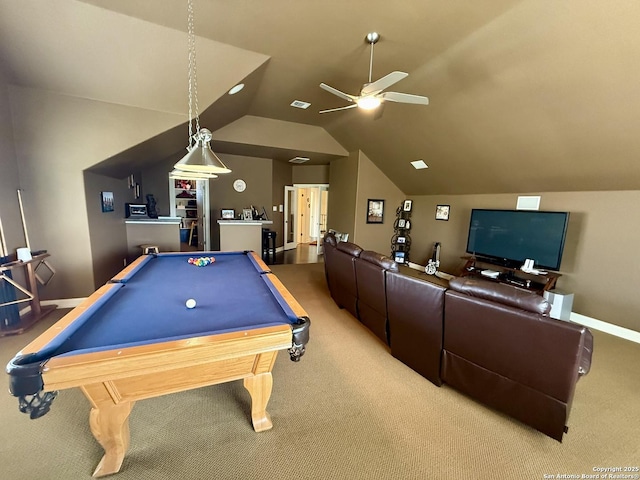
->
xmin=449 ymin=277 xmax=551 ymax=315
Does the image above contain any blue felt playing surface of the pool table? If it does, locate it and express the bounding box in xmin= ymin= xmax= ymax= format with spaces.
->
xmin=39 ymin=252 xmax=298 ymax=358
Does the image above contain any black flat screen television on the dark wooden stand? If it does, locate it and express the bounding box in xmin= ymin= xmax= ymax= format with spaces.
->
xmin=467 ymin=209 xmax=569 ymax=270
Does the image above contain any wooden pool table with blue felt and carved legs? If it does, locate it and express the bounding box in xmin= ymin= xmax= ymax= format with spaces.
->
xmin=7 ymin=252 xmax=310 ymax=476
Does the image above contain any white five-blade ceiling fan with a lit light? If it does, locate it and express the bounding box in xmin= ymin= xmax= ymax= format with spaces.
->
xmin=320 ymin=32 xmax=429 ymax=113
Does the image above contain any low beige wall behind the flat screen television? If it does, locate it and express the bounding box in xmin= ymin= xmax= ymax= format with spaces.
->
xmin=411 ymin=191 xmax=640 ymax=331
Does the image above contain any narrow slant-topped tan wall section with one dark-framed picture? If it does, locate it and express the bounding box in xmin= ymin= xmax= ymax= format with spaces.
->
xmin=353 ymin=152 xmax=405 ymax=255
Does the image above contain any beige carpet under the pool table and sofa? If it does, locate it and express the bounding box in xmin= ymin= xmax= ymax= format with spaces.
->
xmin=0 ymin=264 xmax=640 ymax=480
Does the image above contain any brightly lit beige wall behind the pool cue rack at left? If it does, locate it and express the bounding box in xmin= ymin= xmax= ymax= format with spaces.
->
xmin=8 ymin=87 xmax=183 ymax=299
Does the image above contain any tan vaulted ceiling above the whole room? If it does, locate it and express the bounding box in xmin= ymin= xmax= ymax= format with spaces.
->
xmin=0 ymin=0 xmax=640 ymax=195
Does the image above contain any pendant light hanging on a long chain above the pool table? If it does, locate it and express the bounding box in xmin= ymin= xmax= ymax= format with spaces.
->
xmin=174 ymin=0 xmax=231 ymax=178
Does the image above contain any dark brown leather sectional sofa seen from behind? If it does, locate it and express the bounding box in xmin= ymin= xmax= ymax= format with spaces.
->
xmin=324 ymin=234 xmax=593 ymax=441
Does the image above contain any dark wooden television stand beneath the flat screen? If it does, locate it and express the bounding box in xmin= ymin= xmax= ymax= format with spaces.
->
xmin=459 ymin=257 xmax=562 ymax=295
